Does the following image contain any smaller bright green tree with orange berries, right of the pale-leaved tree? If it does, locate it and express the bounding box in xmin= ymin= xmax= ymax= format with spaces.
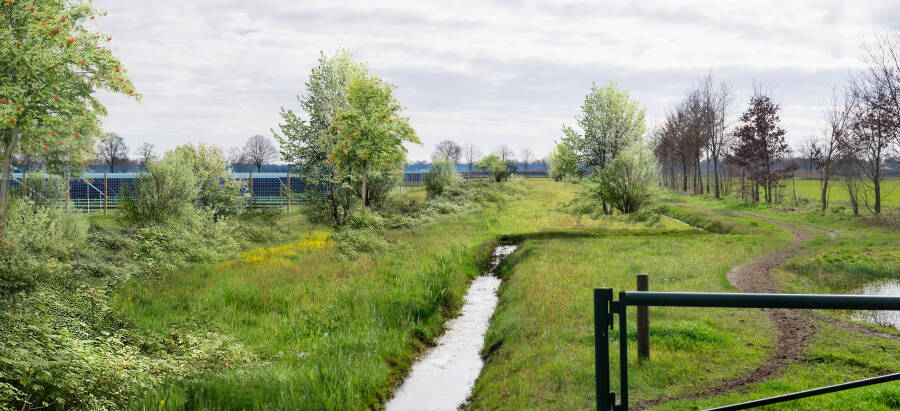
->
xmin=328 ymin=77 xmax=419 ymax=207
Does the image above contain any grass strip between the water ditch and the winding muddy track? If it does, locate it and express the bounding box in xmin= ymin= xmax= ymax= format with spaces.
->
xmin=473 ymin=192 xmax=790 ymax=409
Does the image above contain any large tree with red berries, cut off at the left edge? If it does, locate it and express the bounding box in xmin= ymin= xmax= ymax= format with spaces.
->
xmin=0 ymin=0 xmax=139 ymax=238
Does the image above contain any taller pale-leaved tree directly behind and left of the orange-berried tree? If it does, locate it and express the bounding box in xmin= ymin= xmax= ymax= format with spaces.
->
xmin=272 ymin=50 xmax=369 ymax=225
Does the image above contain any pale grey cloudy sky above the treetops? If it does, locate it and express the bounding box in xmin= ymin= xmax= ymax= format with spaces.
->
xmin=95 ymin=0 xmax=900 ymax=160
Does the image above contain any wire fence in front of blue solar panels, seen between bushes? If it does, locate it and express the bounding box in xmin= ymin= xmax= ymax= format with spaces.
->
xmin=10 ymin=170 xmax=547 ymax=214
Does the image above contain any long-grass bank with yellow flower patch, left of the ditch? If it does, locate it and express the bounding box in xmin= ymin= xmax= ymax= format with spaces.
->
xmin=117 ymin=180 xmax=602 ymax=409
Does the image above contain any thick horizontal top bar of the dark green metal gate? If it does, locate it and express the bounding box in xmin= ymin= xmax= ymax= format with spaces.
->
xmin=619 ymin=291 xmax=900 ymax=310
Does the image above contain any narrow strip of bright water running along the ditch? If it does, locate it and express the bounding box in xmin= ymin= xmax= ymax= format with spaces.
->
xmin=386 ymin=245 xmax=516 ymax=411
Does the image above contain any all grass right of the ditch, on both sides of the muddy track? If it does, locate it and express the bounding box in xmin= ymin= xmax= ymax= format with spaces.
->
xmin=473 ymin=191 xmax=900 ymax=410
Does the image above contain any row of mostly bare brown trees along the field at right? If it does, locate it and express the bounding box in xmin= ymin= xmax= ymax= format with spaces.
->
xmin=654 ymin=32 xmax=900 ymax=215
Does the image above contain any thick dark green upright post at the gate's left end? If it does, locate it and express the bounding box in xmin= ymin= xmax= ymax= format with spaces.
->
xmin=594 ymin=288 xmax=615 ymax=411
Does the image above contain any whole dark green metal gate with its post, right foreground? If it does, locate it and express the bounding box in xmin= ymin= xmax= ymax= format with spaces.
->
xmin=594 ymin=288 xmax=900 ymax=410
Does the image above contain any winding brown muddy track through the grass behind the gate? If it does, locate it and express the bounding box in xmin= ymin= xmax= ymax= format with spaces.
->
xmin=634 ymin=215 xmax=815 ymax=409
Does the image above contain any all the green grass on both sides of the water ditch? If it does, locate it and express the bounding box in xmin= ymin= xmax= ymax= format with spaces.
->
xmin=112 ymin=179 xmax=900 ymax=409
